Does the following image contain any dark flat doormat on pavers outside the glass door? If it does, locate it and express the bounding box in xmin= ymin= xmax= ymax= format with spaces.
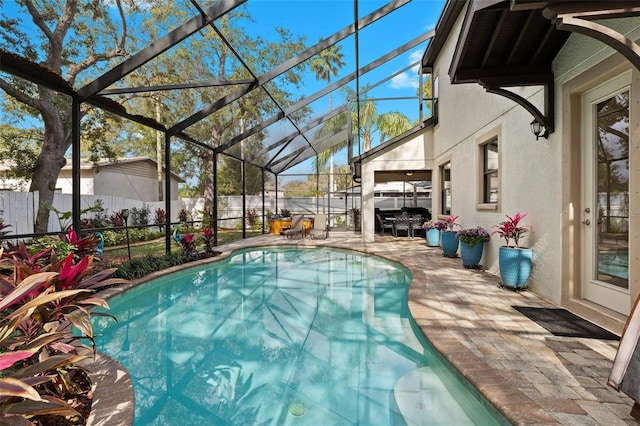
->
xmin=512 ymin=306 xmax=620 ymax=340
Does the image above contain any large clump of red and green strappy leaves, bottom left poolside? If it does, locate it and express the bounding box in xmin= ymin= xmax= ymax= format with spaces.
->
xmin=0 ymin=232 xmax=126 ymax=425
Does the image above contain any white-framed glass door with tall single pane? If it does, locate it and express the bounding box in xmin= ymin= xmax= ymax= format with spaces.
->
xmin=581 ymin=73 xmax=631 ymax=314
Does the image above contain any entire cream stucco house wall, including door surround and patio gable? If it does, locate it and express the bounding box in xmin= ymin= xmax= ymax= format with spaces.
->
xmin=362 ymin=1 xmax=640 ymax=331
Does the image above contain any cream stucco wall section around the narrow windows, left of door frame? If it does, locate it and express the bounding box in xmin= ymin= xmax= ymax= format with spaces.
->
xmin=424 ymin=6 xmax=561 ymax=302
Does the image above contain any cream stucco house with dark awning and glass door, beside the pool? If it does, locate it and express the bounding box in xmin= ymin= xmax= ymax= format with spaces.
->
xmin=354 ymin=0 xmax=640 ymax=332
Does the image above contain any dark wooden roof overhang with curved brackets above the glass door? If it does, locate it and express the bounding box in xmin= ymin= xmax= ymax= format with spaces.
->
xmin=430 ymin=0 xmax=640 ymax=133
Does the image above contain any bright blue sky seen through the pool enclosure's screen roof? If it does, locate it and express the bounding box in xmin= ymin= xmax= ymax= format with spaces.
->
xmin=0 ymin=0 xmax=445 ymax=173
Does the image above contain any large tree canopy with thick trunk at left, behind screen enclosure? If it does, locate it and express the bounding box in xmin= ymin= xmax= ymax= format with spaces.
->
xmin=0 ymin=0 xmax=305 ymax=232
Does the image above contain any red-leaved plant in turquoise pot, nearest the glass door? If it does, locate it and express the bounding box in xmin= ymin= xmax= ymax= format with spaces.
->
xmin=493 ymin=213 xmax=533 ymax=289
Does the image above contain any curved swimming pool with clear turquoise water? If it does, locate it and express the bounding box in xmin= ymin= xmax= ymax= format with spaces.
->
xmin=93 ymin=247 xmax=506 ymax=426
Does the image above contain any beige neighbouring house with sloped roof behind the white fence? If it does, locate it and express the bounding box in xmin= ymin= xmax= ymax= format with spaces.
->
xmin=0 ymin=157 xmax=185 ymax=202
